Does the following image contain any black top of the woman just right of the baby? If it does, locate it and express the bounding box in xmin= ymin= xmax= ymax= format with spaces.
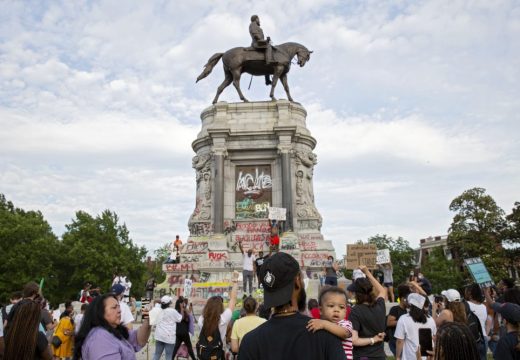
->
xmin=348 ymin=298 xmax=386 ymax=360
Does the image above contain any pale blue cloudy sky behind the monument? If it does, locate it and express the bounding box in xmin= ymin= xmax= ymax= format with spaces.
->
xmin=0 ymin=0 xmax=520 ymax=255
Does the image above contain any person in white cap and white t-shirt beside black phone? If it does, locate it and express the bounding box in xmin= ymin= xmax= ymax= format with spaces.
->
xmin=394 ymin=293 xmax=437 ymax=360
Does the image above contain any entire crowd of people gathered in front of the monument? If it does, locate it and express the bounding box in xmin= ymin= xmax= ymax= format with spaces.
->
xmin=0 ymin=251 xmax=520 ymax=360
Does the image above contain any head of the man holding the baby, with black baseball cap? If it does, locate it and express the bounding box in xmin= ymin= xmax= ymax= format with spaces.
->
xmin=258 ymin=252 xmax=300 ymax=308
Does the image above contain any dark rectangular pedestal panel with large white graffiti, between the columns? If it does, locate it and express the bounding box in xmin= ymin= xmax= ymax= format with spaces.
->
xmin=235 ymin=165 xmax=273 ymax=220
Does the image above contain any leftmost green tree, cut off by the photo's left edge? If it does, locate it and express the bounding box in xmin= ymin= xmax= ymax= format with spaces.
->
xmin=0 ymin=194 xmax=59 ymax=303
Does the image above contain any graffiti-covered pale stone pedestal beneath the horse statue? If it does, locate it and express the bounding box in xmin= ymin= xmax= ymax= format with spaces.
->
xmin=160 ymin=100 xmax=334 ymax=305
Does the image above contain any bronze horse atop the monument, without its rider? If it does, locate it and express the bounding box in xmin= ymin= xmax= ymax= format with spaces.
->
xmin=196 ymin=42 xmax=312 ymax=104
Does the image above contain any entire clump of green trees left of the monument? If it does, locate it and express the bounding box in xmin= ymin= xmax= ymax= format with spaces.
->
xmin=0 ymin=194 xmax=150 ymax=306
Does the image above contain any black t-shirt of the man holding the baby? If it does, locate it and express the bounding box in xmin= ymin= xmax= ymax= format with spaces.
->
xmin=238 ymin=313 xmax=345 ymax=360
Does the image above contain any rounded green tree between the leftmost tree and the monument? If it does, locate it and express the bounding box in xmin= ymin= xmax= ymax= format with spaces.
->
xmin=60 ymin=210 xmax=147 ymax=299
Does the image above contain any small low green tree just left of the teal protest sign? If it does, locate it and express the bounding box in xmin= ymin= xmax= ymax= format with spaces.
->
xmin=421 ymin=247 xmax=469 ymax=294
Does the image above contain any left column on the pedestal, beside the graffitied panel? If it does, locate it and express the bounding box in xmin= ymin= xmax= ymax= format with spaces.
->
xmin=208 ymin=129 xmax=229 ymax=234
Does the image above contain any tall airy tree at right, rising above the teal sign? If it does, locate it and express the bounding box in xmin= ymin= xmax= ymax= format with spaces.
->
xmin=448 ymin=188 xmax=506 ymax=279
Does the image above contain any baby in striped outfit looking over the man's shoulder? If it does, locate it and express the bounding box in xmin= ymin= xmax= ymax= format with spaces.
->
xmin=307 ymin=286 xmax=353 ymax=360
